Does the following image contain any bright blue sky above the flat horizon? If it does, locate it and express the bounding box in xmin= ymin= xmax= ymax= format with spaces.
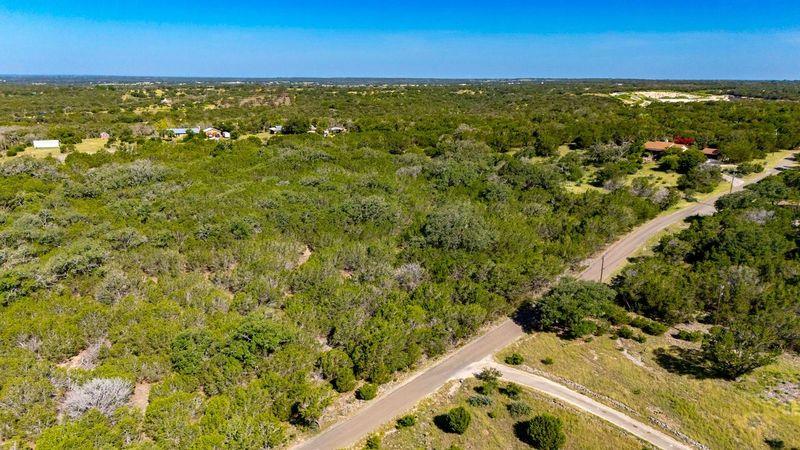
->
xmin=0 ymin=0 xmax=800 ymax=79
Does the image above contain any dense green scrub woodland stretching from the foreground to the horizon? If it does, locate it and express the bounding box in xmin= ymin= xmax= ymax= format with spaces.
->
xmin=0 ymin=82 xmax=800 ymax=448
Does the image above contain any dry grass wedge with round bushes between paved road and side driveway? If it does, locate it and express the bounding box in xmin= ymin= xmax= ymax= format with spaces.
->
xmin=368 ymin=378 xmax=644 ymax=450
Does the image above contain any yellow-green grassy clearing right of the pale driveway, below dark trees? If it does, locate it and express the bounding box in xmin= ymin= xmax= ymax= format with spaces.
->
xmin=498 ymin=333 xmax=800 ymax=449
